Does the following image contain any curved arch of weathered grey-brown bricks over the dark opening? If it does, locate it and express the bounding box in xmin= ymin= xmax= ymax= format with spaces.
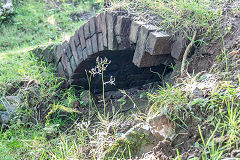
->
xmin=54 ymin=12 xmax=173 ymax=87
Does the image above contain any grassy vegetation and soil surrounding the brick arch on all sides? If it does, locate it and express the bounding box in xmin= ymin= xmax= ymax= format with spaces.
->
xmin=0 ymin=0 xmax=240 ymax=160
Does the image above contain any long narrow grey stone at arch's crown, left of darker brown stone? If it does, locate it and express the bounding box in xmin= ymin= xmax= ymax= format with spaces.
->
xmin=107 ymin=12 xmax=117 ymax=50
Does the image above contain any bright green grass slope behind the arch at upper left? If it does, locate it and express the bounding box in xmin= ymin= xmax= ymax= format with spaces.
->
xmin=0 ymin=0 xmax=99 ymax=53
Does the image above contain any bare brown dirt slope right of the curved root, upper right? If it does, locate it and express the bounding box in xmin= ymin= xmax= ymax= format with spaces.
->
xmin=188 ymin=1 xmax=240 ymax=79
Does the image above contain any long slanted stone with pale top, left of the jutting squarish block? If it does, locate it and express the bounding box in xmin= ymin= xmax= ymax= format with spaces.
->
xmin=133 ymin=25 xmax=157 ymax=67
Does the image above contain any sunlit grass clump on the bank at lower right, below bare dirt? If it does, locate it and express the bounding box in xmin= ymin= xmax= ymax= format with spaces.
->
xmin=148 ymin=71 xmax=240 ymax=160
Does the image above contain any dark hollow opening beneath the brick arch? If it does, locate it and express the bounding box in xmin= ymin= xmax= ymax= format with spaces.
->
xmin=72 ymin=50 xmax=171 ymax=93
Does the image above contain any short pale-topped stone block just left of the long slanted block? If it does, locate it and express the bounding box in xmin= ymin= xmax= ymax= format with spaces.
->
xmin=129 ymin=21 xmax=145 ymax=43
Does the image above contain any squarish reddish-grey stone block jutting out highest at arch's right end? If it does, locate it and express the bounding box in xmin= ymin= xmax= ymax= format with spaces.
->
xmin=145 ymin=32 xmax=171 ymax=55
